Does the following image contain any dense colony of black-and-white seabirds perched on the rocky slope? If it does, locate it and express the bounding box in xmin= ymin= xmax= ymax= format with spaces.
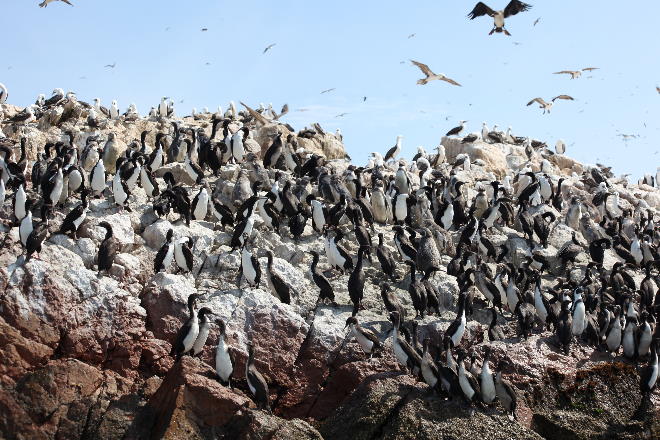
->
xmin=0 ymin=79 xmax=660 ymax=415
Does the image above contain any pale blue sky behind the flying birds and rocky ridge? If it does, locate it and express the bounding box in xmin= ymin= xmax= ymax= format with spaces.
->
xmin=0 ymin=0 xmax=660 ymax=178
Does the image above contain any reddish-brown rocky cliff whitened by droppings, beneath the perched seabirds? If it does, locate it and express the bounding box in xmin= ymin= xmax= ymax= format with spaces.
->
xmin=0 ymin=99 xmax=660 ymax=439
